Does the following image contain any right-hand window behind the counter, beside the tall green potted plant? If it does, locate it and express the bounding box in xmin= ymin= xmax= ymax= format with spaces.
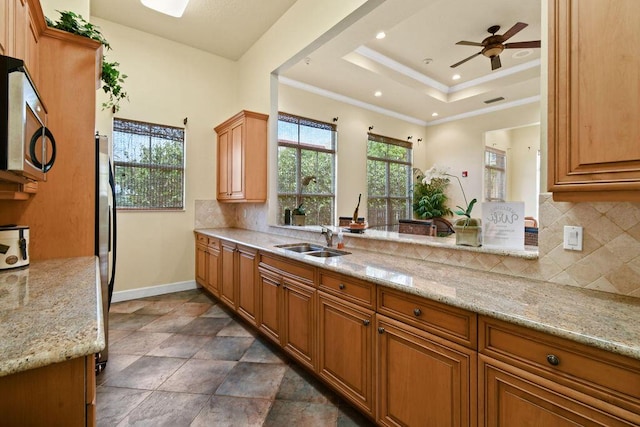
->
xmin=367 ymin=133 xmax=412 ymax=229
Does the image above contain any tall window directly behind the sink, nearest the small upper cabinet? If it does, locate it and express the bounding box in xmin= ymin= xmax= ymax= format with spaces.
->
xmin=278 ymin=113 xmax=337 ymax=225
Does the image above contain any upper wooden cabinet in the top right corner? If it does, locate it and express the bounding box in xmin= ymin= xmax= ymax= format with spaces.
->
xmin=548 ymin=0 xmax=640 ymax=201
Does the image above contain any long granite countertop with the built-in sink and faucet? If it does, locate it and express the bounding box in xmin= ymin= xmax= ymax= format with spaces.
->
xmin=195 ymin=228 xmax=640 ymax=359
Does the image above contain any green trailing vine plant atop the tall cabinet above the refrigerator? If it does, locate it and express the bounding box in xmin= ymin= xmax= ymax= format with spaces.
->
xmin=46 ymin=10 xmax=129 ymax=113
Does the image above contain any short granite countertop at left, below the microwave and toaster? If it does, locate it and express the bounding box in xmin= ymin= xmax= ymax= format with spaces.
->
xmin=0 ymin=257 xmax=105 ymax=376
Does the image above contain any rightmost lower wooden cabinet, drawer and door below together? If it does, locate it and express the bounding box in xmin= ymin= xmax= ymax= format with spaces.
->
xmin=478 ymin=317 xmax=640 ymax=426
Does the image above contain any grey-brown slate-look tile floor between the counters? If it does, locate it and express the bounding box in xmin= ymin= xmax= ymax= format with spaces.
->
xmin=97 ymin=290 xmax=373 ymax=427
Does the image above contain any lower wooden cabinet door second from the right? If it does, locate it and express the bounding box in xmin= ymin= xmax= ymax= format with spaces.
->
xmin=376 ymin=315 xmax=476 ymax=427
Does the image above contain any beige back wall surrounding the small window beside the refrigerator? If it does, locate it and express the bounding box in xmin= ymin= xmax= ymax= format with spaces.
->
xmin=92 ymin=18 xmax=238 ymax=291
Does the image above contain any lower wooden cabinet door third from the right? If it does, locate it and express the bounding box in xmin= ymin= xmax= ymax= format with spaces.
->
xmin=318 ymin=292 xmax=374 ymax=416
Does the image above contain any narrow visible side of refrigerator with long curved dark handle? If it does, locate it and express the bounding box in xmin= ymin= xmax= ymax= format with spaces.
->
xmin=95 ymin=133 xmax=117 ymax=373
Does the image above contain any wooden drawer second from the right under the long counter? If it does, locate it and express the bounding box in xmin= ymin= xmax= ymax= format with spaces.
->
xmin=377 ymin=286 xmax=478 ymax=349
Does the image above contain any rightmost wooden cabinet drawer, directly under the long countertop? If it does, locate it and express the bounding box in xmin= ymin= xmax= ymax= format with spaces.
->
xmin=479 ymin=316 xmax=640 ymax=413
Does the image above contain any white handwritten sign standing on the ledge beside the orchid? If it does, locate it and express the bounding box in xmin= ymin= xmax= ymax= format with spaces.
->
xmin=482 ymin=202 xmax=524 ymax=250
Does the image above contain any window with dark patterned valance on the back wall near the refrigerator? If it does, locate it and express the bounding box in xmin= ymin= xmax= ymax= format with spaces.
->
xmin=113 ymin=119 xmax=184 ymax=210
